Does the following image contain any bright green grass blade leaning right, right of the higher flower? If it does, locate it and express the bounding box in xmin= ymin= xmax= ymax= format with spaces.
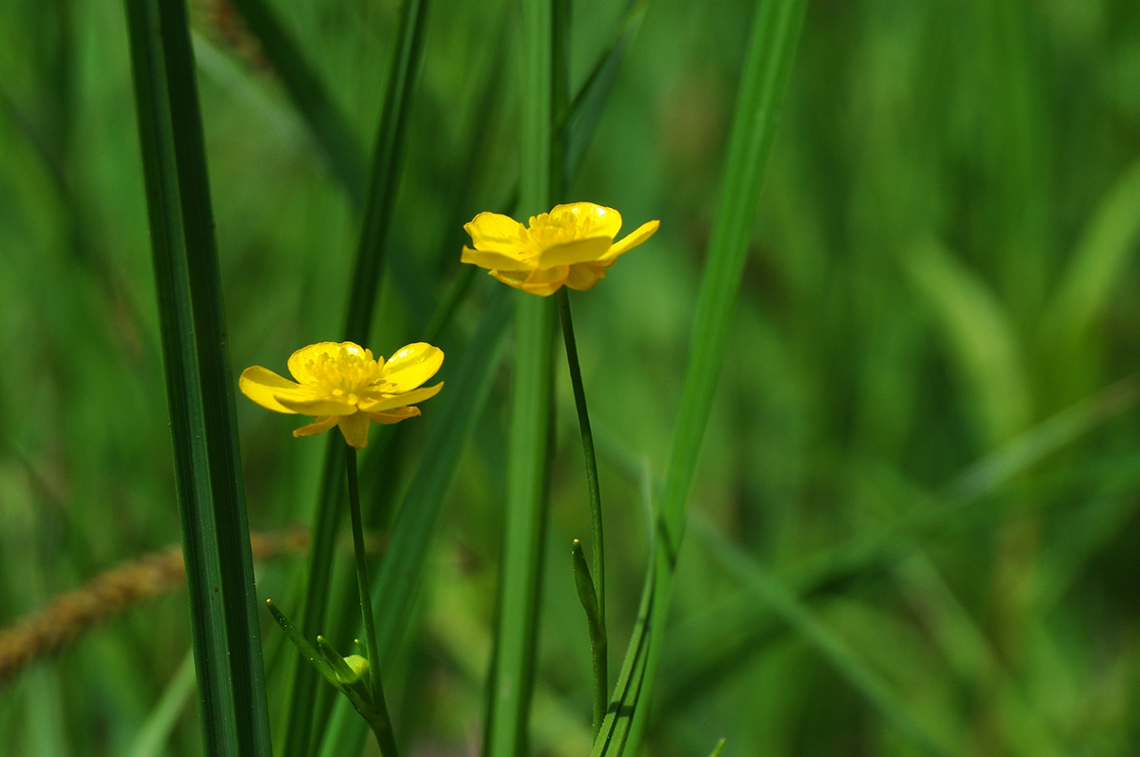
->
xmin=594 ymin=0 xmax=807 ymax=757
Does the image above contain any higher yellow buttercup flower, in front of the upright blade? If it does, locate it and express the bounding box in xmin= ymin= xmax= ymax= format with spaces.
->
xmin=461 ymin=203 xmax=660 ymax=296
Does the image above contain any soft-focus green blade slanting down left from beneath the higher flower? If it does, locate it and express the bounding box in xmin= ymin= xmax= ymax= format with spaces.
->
xmin=310 ymin=287 xmax=512 ymax=757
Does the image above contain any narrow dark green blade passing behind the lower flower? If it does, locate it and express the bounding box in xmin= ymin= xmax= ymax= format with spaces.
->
xmin=285 ymin=0 xmax=428 ymax=757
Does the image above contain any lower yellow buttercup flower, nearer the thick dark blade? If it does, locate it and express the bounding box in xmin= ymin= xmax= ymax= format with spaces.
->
xmin=238 ymin=342 xmax=443 ymax=449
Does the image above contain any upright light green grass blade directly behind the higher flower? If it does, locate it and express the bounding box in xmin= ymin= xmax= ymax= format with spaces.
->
xmin=483 ymin=0 xmax=564 ymax=757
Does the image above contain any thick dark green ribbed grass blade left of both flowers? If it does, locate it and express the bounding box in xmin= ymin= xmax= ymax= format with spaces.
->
xmin=127 ymin=0 xmax=271 ymax=756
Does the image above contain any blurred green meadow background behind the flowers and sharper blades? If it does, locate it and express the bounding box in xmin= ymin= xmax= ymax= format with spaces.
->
xmin=0 ymin=0 xmax=1140 ymax=757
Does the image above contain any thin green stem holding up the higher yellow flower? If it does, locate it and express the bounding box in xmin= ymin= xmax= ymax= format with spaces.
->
xmin=556 ymin=286 xmax=609 ymax=734
